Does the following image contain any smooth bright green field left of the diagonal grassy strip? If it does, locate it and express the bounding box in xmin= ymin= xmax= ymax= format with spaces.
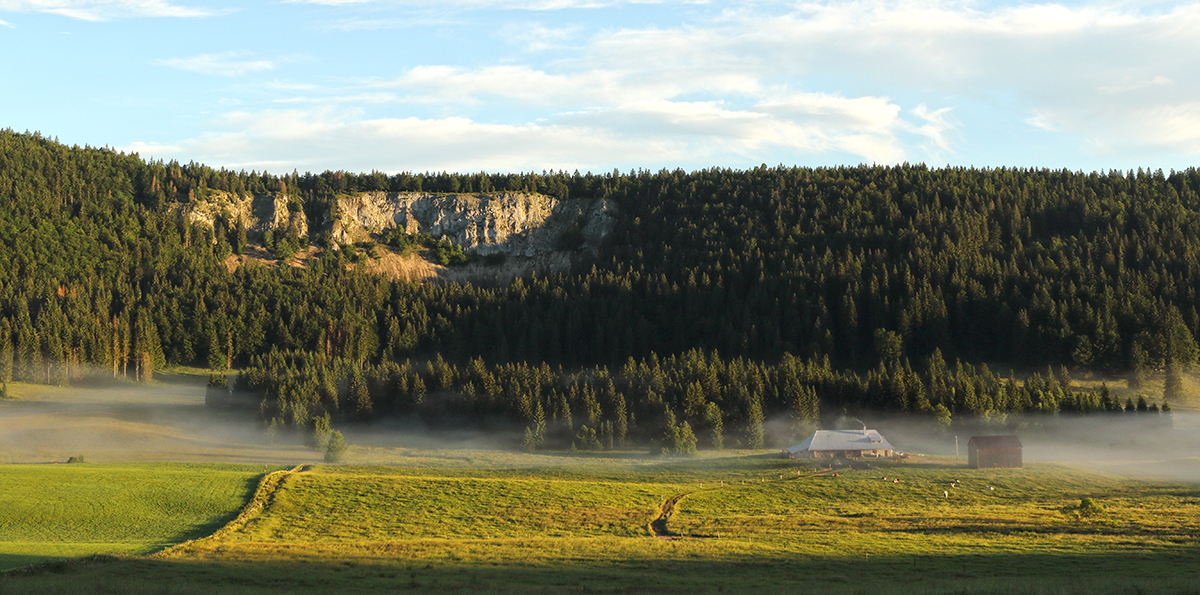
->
xmin=0 ymin=463 xmax=272 ymax=570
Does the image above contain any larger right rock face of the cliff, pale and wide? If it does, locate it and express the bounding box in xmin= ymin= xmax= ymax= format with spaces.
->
xmin=325 ymin=192 xmax=614 ymax=257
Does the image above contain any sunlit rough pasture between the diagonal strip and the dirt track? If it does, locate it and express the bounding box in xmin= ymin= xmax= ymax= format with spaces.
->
xmin=227 ymin=467 xmax=661 ymax=545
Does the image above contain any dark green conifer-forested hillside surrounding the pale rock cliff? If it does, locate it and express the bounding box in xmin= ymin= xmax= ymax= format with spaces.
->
xmin=0 ymin=131 xmax=1200 ymax=450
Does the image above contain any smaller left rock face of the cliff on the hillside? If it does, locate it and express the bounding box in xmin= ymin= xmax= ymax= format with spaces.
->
xmin=175 ymin=191 xmax=308 ymax=238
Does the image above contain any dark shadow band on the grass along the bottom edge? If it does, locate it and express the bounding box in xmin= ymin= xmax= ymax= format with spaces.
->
xmin=0 ymin=545 xmax=1200 ymax=595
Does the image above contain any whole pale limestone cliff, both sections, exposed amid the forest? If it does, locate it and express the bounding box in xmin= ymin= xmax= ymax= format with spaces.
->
xmin=174 ymin=191 xmax=616 ymax=283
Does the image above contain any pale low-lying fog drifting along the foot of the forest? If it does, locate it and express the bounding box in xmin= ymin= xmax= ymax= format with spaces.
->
xmin=0 ymin=384 xmax=1200 ymax=483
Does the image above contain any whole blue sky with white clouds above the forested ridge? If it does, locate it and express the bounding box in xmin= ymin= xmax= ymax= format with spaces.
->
xmin=0 ymin=0 xmax=1200 ymax=174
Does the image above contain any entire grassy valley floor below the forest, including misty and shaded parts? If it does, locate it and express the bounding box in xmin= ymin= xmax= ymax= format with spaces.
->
xmin=0 ymin=374 xmax=1200 ymax=595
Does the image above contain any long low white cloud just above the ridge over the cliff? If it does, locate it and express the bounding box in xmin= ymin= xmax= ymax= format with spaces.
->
xmin=171 ymin=109 xmax=686 ymax=172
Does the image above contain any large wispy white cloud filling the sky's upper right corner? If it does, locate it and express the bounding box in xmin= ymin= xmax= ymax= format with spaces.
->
xmin=581 ymin=0 xmax=1200 ymax=159
